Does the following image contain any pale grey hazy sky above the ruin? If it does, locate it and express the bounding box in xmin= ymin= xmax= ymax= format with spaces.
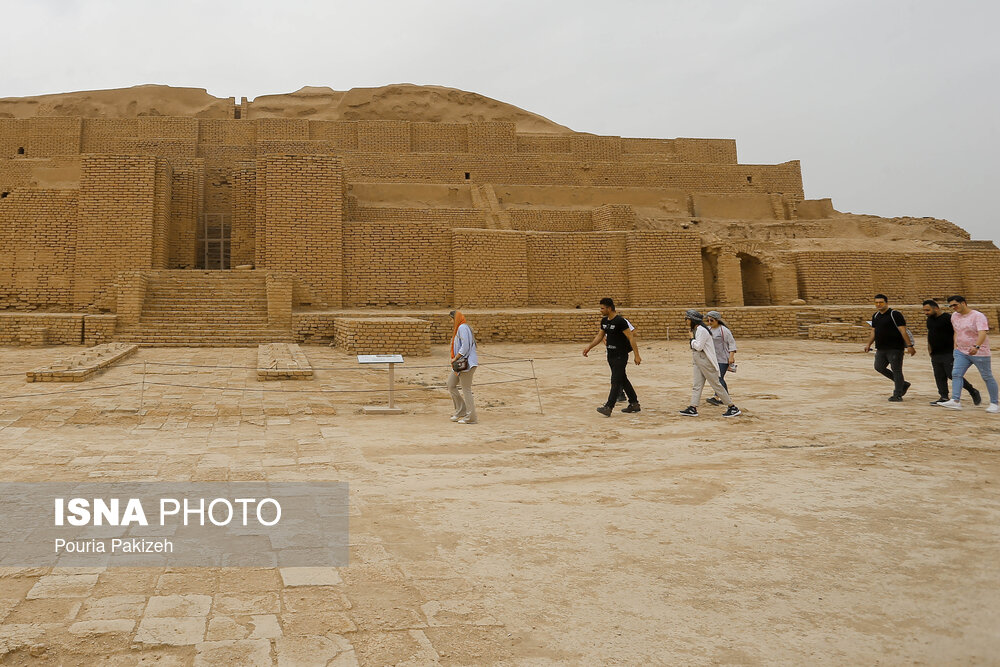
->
xmin=0 ymin=0 xmax=1000 ymax=245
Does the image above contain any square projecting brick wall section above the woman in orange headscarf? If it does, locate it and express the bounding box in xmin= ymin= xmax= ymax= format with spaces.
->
xmin=451 ymin=229 xmax=528 ymax=308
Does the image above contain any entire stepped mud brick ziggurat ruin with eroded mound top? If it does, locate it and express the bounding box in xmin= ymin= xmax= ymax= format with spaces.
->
xmin=0 ymin=86 xmax=1000 ymax=352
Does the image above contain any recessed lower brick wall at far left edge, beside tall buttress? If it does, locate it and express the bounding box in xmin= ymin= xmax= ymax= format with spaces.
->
xmin=0 ymin=190 xmax=78 ymax=310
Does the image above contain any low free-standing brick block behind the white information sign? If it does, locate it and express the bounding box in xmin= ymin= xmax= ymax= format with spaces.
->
xmin=333 ymin=317 xmax=431 ymax=357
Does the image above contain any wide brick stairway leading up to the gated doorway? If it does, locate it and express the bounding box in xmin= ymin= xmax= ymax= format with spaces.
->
xmin=115 ymin=271 xmax=294 ymax=347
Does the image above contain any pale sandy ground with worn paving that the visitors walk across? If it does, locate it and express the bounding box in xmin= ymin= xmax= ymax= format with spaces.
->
xmin=0 ymin=342 xmax=1000 ymax=665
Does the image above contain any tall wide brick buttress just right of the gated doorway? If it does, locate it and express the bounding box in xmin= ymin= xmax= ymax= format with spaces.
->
xmin=255 ymin=155 xmax=344 ymax=307
